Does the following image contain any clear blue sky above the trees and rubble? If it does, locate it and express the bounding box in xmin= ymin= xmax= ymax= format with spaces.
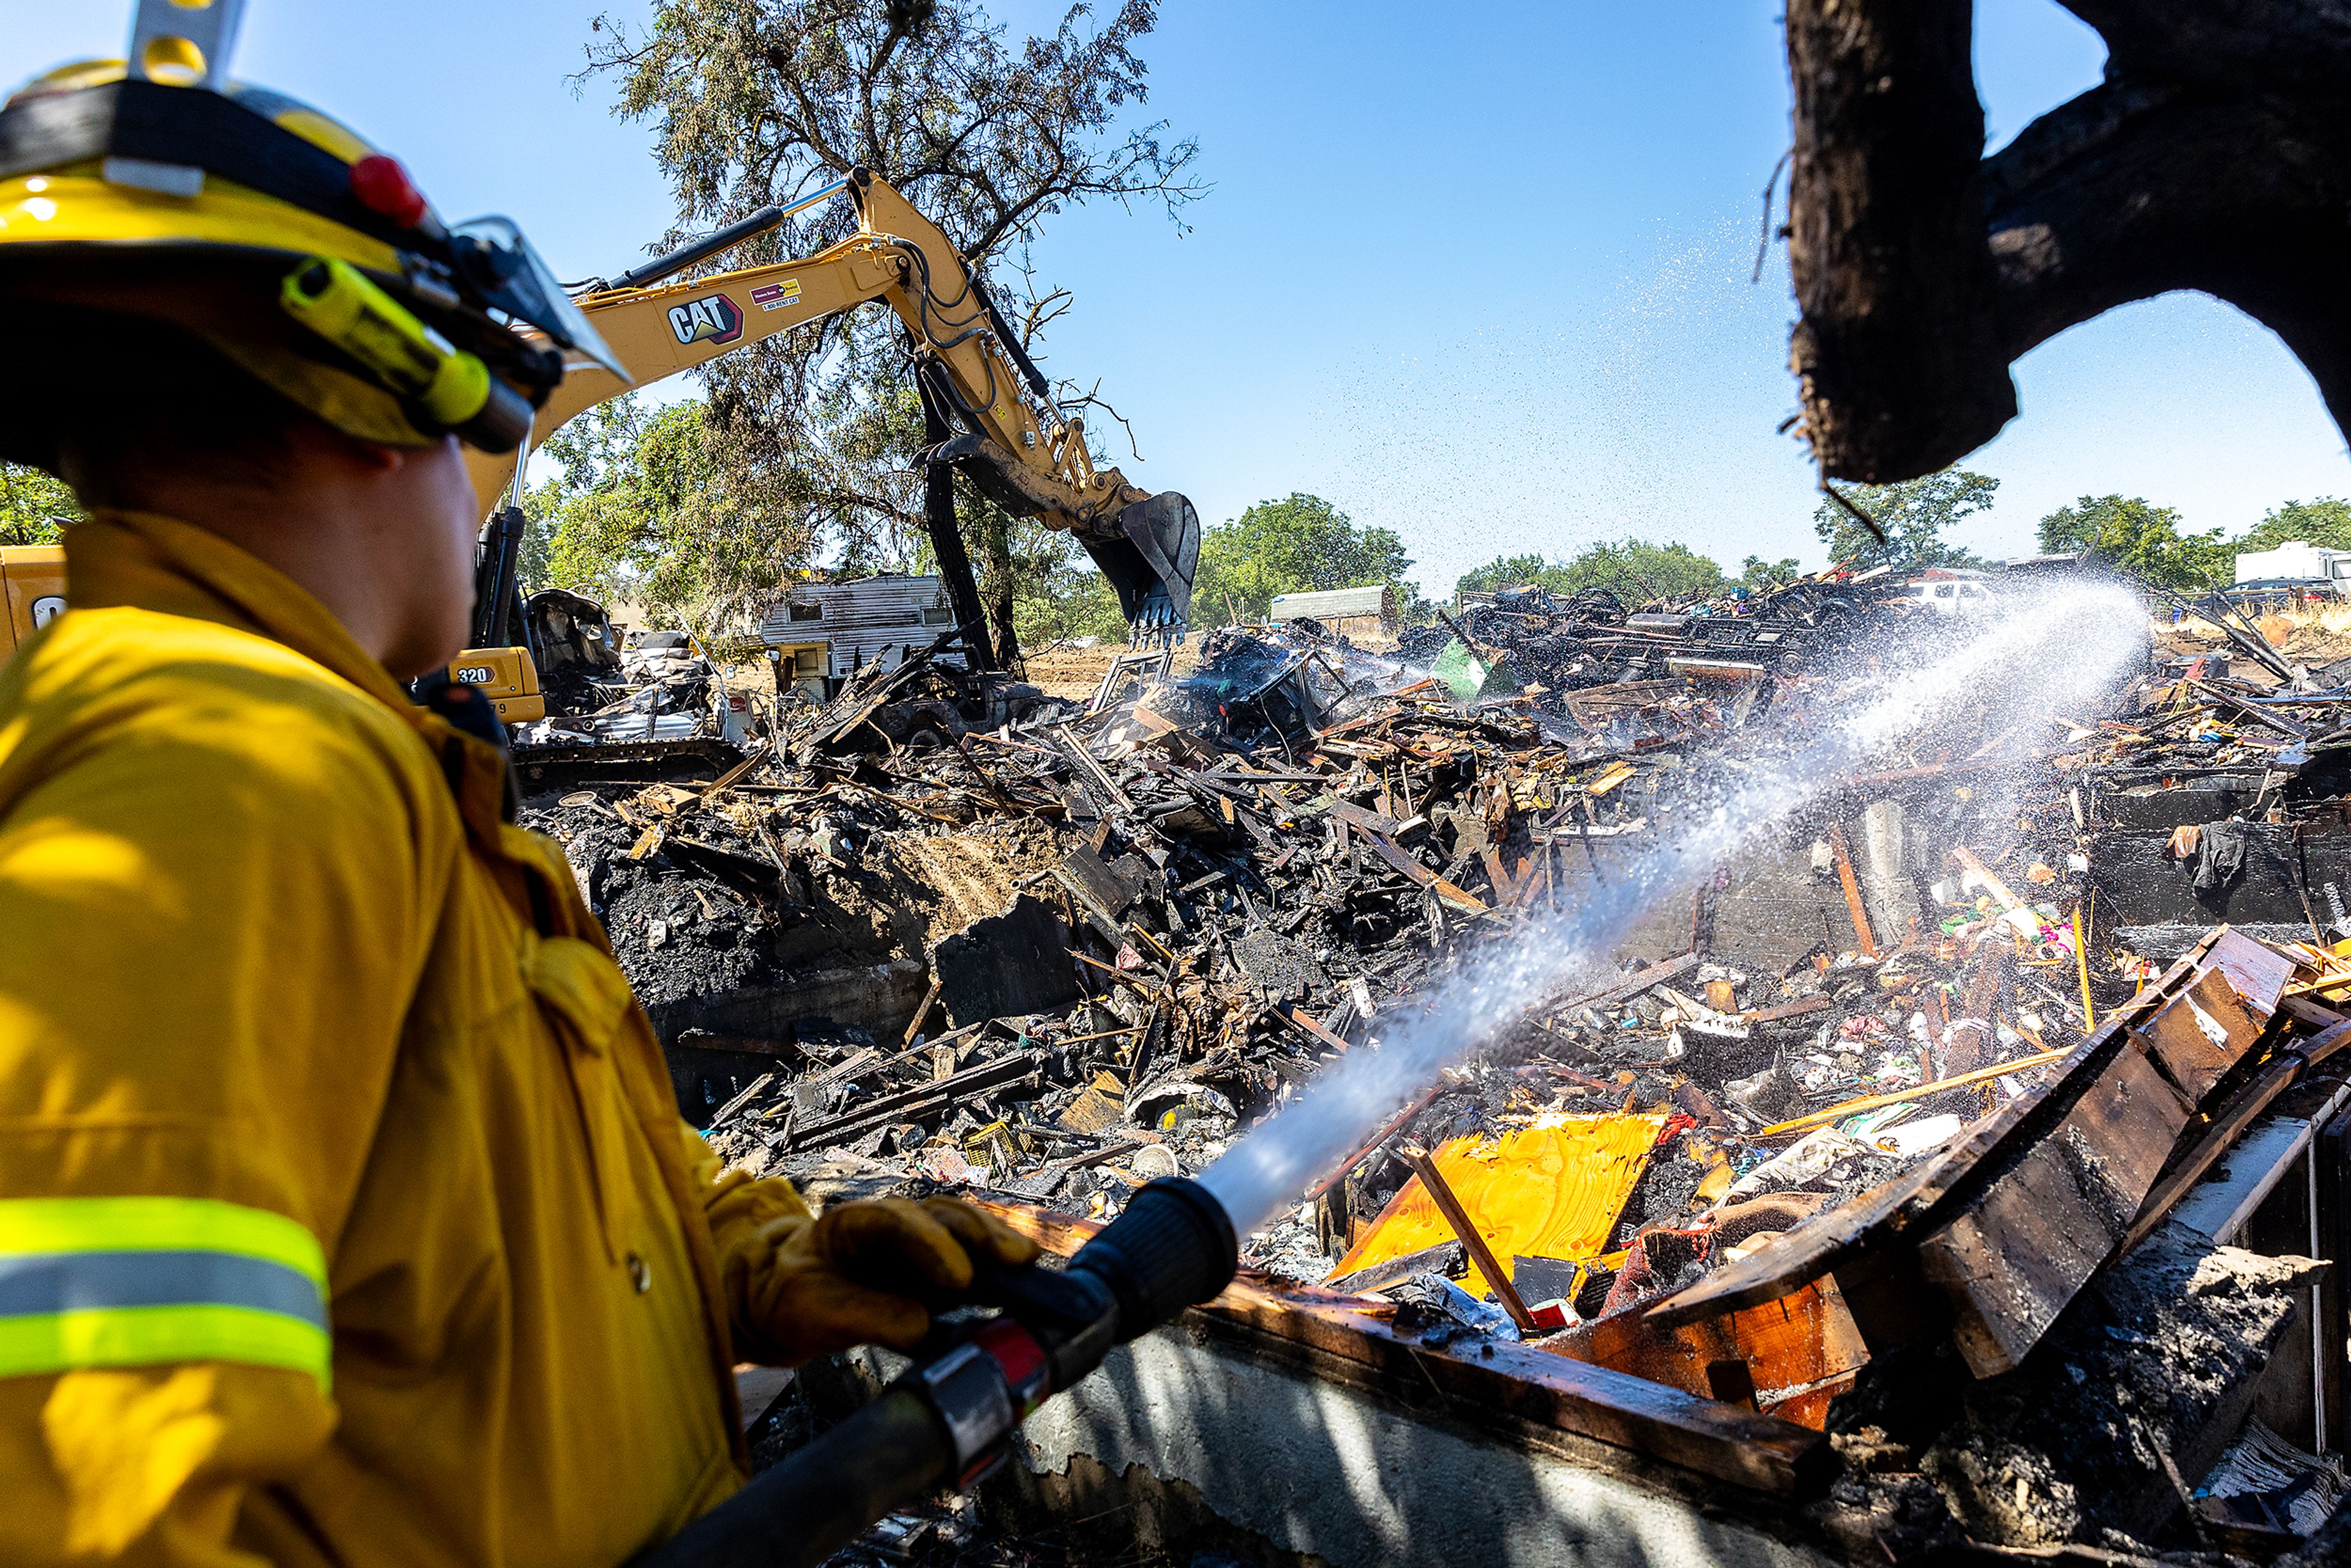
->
xmin=0 ymin=0 xmax=2351 ymax=590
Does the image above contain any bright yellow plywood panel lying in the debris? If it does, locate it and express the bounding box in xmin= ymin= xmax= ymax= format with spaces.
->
xmin=1330 ymin=1114 xmax=1665 ymax=1279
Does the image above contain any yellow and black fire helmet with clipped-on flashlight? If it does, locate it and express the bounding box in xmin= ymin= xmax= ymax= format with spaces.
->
xmin=0 ymin=0 xmax=621 ymax=461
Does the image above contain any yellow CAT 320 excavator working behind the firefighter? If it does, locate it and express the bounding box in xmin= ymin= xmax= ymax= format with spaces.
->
xmin=0 ymin=167 xmax=1199 ymax=722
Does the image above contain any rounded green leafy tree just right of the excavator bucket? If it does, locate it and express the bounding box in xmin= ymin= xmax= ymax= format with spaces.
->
xmin=1192 ymin=493 xmax=1420 ymax=625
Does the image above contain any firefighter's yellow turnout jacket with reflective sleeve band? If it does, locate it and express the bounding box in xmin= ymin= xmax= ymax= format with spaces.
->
xmin=0 ymin=512 xmax=804 ymax=1568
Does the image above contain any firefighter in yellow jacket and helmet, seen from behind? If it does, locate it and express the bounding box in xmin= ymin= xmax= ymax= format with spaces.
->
xmin=0 ymin=34 xmax=1032 ymax=1568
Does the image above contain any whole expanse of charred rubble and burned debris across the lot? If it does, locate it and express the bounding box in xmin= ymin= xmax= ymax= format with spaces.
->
xmin=524 ymin=595 xmax=2351 ymax=1545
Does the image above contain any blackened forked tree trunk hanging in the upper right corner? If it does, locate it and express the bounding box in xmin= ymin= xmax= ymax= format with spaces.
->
xmin=1787 ymin=0 xmax=2351 ymax=484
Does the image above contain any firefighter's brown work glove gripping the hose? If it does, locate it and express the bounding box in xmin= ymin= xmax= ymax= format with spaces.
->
xmin=745 ymin=1199 xmax=1037 ymax=1366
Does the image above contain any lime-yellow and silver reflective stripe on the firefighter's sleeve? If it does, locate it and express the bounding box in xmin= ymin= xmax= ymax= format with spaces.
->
xmin=0 ymin=1196 xmax=329 ymax=1389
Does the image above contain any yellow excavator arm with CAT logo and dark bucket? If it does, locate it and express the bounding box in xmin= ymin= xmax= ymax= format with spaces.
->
xmin=470 ymin=169 xmax=1199 ymax=635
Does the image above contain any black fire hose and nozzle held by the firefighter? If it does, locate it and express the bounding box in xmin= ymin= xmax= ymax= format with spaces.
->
xmin=630 ymin=1178 xmax=1239 ymax=1568
